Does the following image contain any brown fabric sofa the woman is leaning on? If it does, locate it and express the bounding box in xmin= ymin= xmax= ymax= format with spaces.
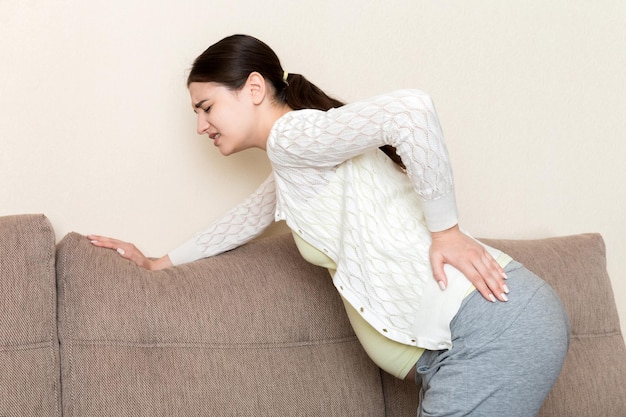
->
xmin=0 ymin=215 xmax=626 ymax=417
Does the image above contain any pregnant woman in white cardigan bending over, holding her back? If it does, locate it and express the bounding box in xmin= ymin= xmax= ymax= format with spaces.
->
xmin=89 ymin=35 xmax=569 ymax=416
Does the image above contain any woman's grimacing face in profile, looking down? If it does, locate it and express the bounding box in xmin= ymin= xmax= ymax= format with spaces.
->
xmin=189 ymin=82 xmax=259 ymax=155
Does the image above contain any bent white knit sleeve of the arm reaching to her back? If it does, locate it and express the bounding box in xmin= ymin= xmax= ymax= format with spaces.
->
xmin=267 ymin=90 xmax=458 ymax=231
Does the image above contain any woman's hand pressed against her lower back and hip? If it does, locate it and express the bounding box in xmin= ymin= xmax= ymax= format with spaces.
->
xmin=430 ymin=225 xmax=509 ymax=302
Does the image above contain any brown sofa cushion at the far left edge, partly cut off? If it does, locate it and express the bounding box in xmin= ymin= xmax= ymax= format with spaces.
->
xmin=0 ymin=215 xmax=61 ymax=417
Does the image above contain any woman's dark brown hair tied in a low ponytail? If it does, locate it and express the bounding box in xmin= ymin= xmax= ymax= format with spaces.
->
xmin=187 ymin=35 xmax=404 ymax=167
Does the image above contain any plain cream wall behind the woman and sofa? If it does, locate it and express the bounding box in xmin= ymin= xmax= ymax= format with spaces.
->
xmin=0 ymin=0 xmax=626 ymax=336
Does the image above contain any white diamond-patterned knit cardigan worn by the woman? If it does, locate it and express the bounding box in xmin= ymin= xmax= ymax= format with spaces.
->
xmin=168 ymin=90 xmax=500 ymax=349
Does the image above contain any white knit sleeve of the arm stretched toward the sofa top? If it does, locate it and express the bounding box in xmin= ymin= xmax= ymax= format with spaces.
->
xmin=168 ymin=174 xmax=276 ymax=265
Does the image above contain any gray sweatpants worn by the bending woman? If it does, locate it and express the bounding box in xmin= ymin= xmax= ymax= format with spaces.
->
xmin=416 ymin=261 xmax=569 ymax=417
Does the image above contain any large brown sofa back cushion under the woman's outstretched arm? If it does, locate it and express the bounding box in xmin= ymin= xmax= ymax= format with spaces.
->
xmin=57 ymin=233 xmax=385 ymax=417
